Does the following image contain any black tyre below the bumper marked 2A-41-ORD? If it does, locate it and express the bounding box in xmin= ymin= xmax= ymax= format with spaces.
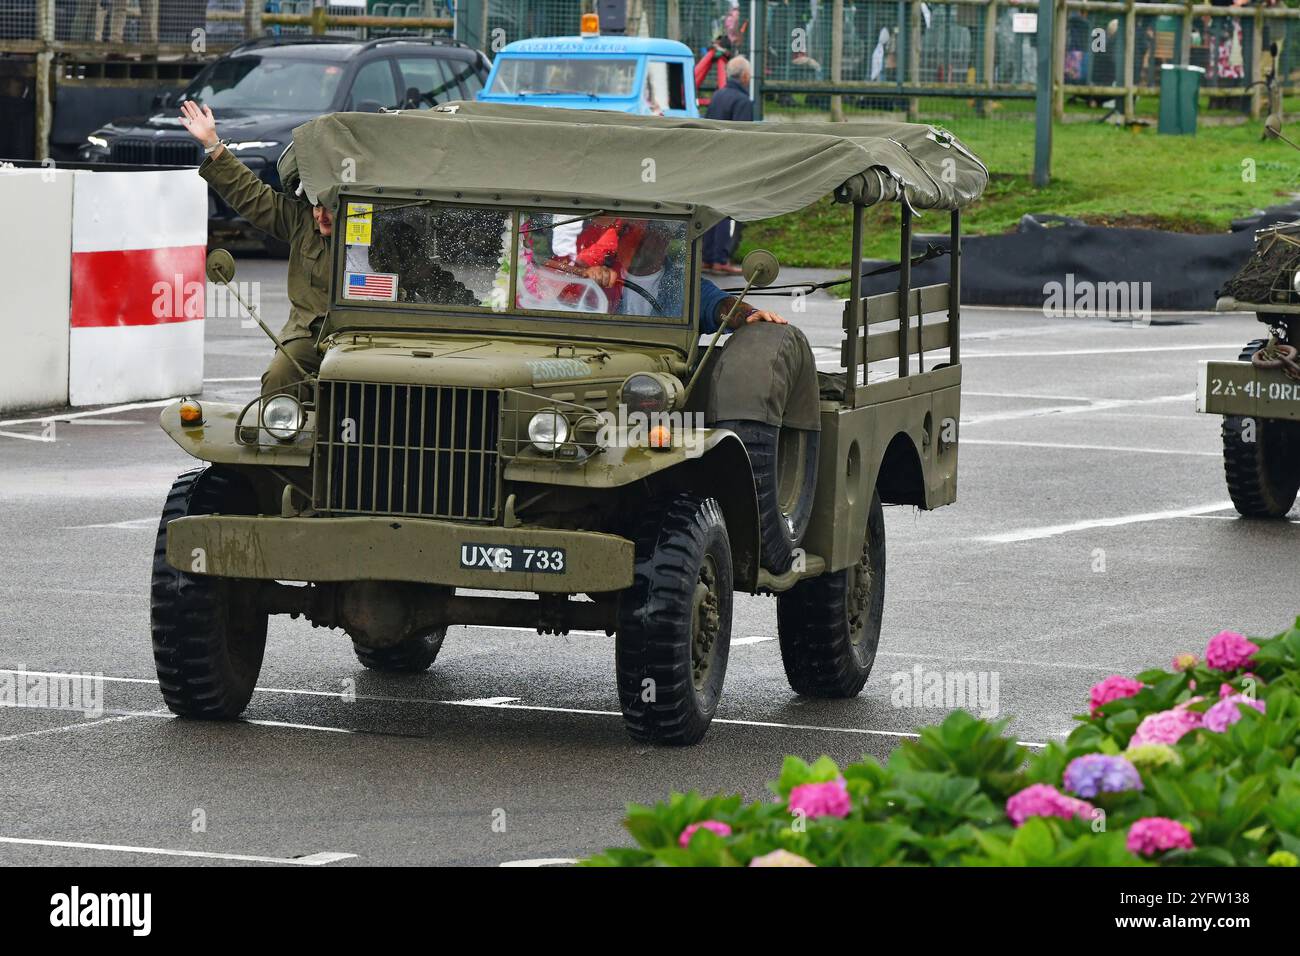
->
xmin=1222 ymin=339 xmax=1300 ymax=518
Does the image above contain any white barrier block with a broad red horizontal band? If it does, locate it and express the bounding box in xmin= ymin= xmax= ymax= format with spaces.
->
xmin=68 ymin=169 xmax=208 ymax=406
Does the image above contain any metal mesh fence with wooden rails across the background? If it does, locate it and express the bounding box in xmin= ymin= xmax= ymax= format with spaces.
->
xmin=0 ymin=0 xmax=1300 ymax=125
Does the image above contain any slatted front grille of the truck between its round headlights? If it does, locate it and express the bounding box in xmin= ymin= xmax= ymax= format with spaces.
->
xmin=316 ymin=381 xmax=501 ymax=522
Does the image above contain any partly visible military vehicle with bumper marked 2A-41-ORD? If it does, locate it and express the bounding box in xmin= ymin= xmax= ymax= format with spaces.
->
xmin=1196 ymin=222 xmax=1300 ymax=518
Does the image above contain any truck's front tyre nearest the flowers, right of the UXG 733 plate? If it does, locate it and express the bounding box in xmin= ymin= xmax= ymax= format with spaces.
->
xmin=614 ymin=494 xmax=732 ymax=745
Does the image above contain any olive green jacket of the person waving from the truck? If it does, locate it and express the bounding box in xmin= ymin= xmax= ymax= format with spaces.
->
xmin=199 ymin=150 xmax=330 ymax=342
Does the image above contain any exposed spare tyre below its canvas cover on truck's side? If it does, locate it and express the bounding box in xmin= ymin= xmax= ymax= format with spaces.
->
xmin=716 ymin=421 xmax=822 ymax=574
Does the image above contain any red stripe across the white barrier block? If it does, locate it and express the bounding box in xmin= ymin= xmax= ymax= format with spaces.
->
xmin=70 ymin=246 xmax=207 ymax=329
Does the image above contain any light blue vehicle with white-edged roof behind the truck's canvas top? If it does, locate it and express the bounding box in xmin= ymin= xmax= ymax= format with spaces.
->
xmin=478 ymin=35 xmax=699 ymax=116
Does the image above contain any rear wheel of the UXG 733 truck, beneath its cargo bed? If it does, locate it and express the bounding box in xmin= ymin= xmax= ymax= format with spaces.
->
xmin=776 ymin=492 xmax=885 ymax=697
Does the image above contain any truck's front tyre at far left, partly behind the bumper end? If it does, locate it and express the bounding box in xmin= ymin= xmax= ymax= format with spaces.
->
xmin=150 ymin=467 xmax=267 ymax=719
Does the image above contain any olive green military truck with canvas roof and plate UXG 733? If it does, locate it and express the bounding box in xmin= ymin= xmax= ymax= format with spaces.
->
xmin=152 ymin=104 xmax=988 ymax=744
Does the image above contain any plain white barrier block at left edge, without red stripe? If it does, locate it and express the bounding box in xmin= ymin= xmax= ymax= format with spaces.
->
xmin=0 ymin=169 xmax=75 ymax=411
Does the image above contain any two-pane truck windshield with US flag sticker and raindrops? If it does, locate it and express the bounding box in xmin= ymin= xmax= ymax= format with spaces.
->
xmin=335 ymin=202 xmax=690 ymax=321
